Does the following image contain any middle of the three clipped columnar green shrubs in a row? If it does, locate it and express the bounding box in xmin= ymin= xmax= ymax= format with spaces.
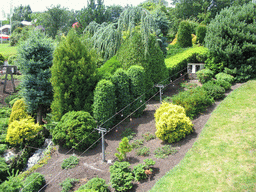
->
xmin=111 ymin=69 xmax=130 ymax=119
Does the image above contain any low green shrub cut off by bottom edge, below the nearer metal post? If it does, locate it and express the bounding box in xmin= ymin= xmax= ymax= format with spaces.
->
xmin=78 ymin=176 xmax=110 ymax=192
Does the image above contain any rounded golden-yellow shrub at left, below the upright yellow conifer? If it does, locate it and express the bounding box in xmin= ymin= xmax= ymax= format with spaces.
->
xmin=6 ymin=117 xmax=42 ymax=145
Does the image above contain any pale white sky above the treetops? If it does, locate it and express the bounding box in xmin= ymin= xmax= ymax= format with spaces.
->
xmin=0 ymin=0 xmax=172 ymax=20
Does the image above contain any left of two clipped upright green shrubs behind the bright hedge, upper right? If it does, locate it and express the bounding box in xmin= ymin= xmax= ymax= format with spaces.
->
xmin=177 ymin=21 xmax=192 ymax=47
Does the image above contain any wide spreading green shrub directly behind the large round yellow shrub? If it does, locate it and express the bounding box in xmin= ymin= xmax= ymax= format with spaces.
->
xmin=172 ymin=87 xmax=214 ymax=119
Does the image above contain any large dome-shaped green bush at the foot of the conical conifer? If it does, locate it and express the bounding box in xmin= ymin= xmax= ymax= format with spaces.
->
xmin=52 ymin=111 xmax=99 ymax=150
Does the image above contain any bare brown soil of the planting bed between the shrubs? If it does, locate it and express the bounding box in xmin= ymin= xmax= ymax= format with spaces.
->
xmin=0 ymin=77 xmax=241 ymax=192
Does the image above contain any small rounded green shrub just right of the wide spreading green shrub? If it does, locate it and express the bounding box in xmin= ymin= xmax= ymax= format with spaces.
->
xmin=202 ymin=81 xmax=225 ymax=99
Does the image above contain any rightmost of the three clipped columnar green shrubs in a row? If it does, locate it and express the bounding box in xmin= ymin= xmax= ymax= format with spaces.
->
xmin=127 ymin=65 xmax=146 ymax=117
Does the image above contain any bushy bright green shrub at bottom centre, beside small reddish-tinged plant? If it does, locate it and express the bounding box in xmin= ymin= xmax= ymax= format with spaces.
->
xmin=109 ymin=161 xmax=134 ymax=191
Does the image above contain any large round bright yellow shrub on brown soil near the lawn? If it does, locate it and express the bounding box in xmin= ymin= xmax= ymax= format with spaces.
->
xmin=155 ymin=103 xmax=193 ymax=143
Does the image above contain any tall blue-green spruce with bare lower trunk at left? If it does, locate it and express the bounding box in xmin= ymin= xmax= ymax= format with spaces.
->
xmin=18 ymin=31 xmax=53 ymax=124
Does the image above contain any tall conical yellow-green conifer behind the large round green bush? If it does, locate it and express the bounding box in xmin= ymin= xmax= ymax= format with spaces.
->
xmin=51 ymin=30 xmax=97 ymax=120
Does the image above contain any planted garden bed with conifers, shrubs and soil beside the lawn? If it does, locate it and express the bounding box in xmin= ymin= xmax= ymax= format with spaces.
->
xmin=0 ymin=3 xmax=256 ymax=192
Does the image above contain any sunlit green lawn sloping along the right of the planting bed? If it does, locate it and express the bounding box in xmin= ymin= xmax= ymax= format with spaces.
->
xmin=151 ymin=80 xmax=256 ymax=192
